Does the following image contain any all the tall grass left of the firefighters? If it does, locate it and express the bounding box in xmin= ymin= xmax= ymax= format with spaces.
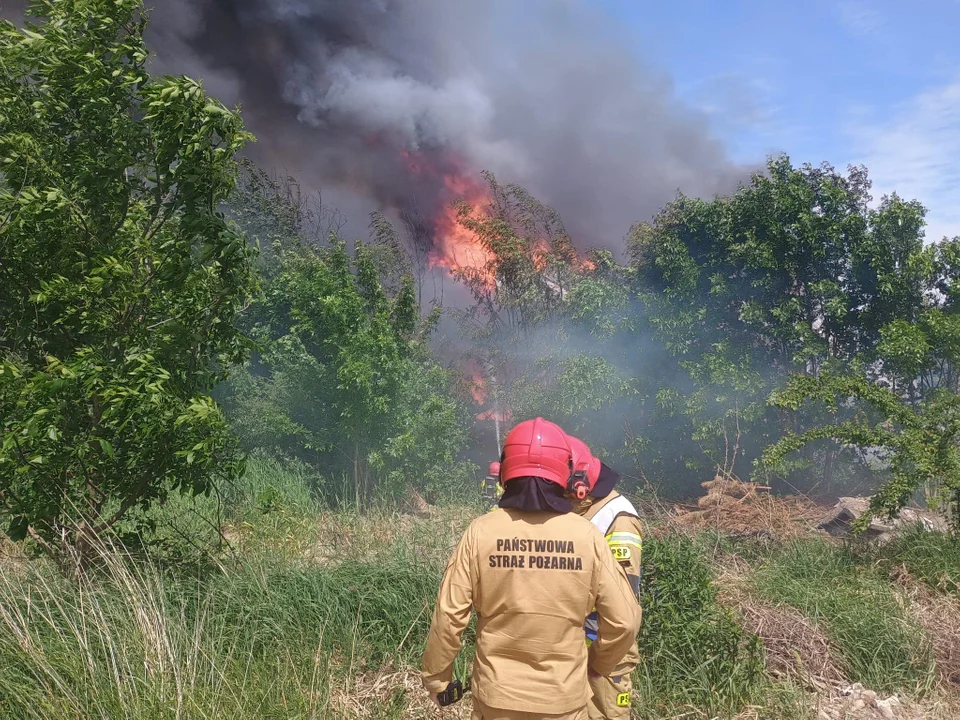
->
xmin=0 ymin=460 xmax=464 ymax=720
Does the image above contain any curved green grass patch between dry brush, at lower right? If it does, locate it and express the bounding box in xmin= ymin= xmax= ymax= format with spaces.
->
xmin=754 ymin=540 xmax=934 ymax=694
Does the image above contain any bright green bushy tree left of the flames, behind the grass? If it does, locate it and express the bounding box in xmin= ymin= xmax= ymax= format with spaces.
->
xmin=218 ymin=168 xmax=470 ymax=502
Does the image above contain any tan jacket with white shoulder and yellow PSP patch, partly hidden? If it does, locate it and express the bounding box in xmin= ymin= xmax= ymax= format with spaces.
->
xmin=584 ymin=490 xmax=643 ymax=674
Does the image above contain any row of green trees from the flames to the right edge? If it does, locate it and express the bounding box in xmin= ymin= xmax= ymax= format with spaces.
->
xmin=461 ymin=157 xmax=960 ymax=509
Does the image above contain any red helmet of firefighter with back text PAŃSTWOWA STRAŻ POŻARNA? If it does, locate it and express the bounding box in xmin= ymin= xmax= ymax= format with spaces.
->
xmin=500 ymin=417 xmax=573 ymax=488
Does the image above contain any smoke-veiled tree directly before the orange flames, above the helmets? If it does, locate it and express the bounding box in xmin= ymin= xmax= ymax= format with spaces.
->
xmin=438 ymin=173 xmax=635 ymax=456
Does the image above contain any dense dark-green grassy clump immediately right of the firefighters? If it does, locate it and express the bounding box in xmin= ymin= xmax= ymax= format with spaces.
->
xmin=637 ymin=534 xmax=764 ymax=717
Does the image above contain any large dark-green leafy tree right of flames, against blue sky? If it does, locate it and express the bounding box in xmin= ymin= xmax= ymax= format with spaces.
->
xmin=629 ymin=158 xmax=943 ymax=496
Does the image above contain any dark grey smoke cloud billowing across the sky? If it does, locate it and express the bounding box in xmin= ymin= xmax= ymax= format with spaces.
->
xmin=2 ymin=0 xmax=746 ymax=253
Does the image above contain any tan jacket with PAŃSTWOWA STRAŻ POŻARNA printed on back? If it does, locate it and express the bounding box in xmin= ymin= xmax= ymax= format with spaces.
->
xmin=423 ymin=509 xmax=640 ymax=715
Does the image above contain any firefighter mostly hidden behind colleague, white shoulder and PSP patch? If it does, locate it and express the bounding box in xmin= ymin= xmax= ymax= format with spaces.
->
xmin=568 ymin=436 xmax=642 ymax=720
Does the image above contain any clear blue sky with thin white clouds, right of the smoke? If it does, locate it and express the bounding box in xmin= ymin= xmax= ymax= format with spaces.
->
xmin=598 ymin=0 xmax=960 ymax=239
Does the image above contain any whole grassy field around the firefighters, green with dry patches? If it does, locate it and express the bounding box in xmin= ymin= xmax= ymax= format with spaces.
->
xmin=0 ymin=452 xmax=960 ymax=720
